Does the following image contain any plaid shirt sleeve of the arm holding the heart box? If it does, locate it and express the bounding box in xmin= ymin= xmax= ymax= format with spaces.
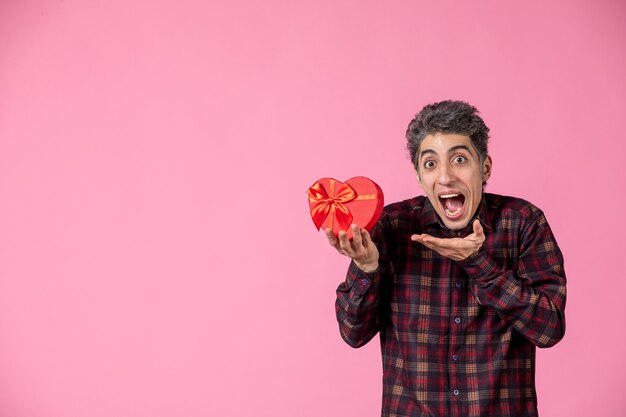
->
xmin=335 ymin=219 xmax=389 ymax=348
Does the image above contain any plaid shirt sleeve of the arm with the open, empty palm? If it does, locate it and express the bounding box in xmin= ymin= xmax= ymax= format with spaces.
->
xmin=457 ymin=212 xmax=566 ymax=348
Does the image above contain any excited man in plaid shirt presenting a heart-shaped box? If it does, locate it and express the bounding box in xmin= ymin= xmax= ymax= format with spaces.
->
xmin=326 ymin=101 xmax=566 ymax=417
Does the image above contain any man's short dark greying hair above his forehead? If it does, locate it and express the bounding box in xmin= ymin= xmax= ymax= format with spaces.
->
xmin=406 ymin=100 xmax=489 ymax=170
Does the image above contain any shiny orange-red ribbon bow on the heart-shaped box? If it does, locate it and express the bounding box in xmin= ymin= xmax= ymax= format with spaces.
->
xmin=308 ymin=178 xmax=357 ymax=230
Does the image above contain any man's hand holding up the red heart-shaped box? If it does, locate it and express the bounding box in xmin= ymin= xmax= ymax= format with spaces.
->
xmin=325 ymin=224 xmax=379 ymax=273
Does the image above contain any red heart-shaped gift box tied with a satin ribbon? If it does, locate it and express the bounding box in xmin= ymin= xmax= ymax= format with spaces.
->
xmin=308 ymin=177 xmax=384 ymax=239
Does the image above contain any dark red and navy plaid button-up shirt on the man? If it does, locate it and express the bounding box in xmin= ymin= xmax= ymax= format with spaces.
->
xmin=336 ymin=193 xmax=566 ymax=417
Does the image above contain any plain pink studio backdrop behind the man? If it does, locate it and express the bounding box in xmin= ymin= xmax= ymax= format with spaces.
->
xmin=0 ymin=0 xmax=626 ymax=417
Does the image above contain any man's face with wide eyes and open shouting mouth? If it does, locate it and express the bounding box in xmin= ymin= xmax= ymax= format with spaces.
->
xmin=417 ymin=133 xmax=491 ymax=230
